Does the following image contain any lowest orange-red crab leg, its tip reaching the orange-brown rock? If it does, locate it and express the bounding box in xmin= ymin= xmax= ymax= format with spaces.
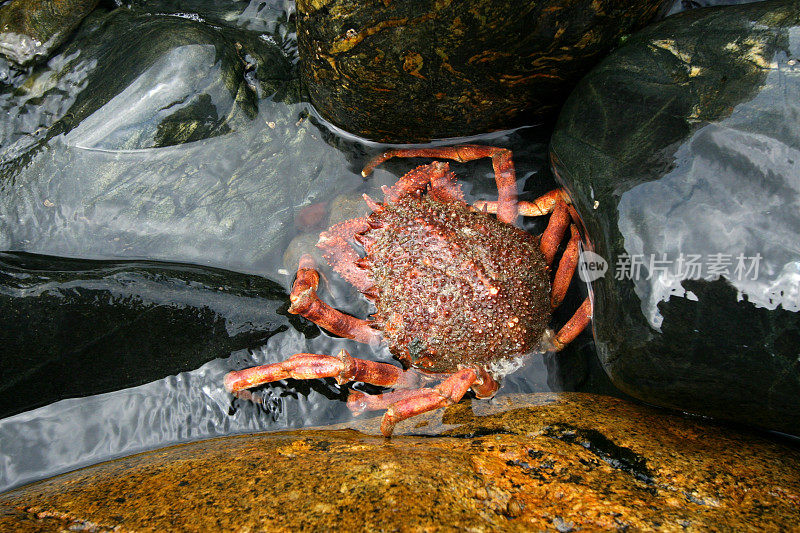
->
xmin=381 ymin=368 xmax=497 ymax=437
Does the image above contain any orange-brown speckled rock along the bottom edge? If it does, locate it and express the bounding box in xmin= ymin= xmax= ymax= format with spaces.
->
xmin=0 ymin=394 xmax=800 ymax=531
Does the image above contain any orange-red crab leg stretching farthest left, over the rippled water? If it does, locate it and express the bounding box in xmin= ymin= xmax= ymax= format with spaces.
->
xmin=225 ymin=350 xmax=419 ymax=392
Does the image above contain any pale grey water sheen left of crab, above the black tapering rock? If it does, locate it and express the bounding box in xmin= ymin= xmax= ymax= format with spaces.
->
xmin=0 ymin=105 xmax=354 ymax=273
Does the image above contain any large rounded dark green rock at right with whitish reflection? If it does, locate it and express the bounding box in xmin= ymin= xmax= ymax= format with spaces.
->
xmin=551 ymin=0 xmax=800 ymax=434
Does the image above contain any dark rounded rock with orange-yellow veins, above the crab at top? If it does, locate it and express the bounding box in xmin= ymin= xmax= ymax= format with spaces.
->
xmin=297 ymin=0 xmax=673 ymax=143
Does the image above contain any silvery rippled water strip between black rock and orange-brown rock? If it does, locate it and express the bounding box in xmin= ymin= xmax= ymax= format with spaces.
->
xmin=0 ymin=332 xmax=346 ymax=490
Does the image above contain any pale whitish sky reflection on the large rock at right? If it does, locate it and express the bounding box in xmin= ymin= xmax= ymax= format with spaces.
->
xmin=618 ymin=37 xmax=800 ymax=328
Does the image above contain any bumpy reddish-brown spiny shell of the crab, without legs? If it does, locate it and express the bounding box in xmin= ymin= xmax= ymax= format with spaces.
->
xmin=321 ymin=163 xmax=551 ymax=373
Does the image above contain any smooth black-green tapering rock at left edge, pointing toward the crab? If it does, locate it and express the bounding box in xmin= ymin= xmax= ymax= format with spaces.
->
xmin=0 ymin=253 xmax=289 ymax=418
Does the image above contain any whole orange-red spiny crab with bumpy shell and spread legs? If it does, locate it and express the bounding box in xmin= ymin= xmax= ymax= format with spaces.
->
xmin=224 ymin=145 xmax=591 ymax=437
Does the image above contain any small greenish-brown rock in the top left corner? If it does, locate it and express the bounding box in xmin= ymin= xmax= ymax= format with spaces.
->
xmin=0 ymin=0 xmax=98 ymax=65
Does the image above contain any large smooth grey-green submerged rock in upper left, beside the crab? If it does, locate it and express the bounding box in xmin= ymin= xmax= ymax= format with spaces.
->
xmin=0 ymin=7 xmax=350 ymax=273
